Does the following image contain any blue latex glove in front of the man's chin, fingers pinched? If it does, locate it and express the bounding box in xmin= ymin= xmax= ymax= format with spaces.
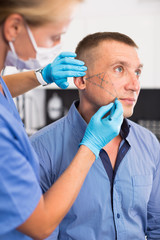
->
xmin=80 ymin=100 xmax=123 ymax=159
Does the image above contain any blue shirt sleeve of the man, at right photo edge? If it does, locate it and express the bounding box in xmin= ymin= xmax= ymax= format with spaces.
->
xmin=147 ymin=143 xmax=160 ymax=240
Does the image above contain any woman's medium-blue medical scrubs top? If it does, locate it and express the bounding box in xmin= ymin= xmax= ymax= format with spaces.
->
xmin=0 ymin=77 xmax=42 ymax=240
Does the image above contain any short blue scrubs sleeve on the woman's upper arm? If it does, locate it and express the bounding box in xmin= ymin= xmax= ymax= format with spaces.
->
xmin=0 ymin=121 xmax=42 ymax=235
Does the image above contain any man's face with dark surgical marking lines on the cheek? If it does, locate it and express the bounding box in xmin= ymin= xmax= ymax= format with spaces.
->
xmin=83 ymin=41 xmax=142 ymax=117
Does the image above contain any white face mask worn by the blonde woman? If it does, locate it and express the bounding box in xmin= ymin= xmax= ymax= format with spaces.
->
xmin=5 ymin=26 xmax=61 ymax=70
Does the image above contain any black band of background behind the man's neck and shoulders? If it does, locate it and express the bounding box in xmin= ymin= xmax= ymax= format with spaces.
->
xmin=46 ymin=89 xmax=160 ymax=140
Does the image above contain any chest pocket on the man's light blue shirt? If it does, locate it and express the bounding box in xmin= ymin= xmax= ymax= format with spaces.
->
xmin=131 ymin=175 xmax=153 ymax=216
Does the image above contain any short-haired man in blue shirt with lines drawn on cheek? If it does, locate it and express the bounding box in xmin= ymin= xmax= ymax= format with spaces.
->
xmin=31 ymin=32 xmax=160 ymax=240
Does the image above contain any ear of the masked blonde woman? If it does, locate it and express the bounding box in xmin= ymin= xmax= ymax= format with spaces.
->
xmin=4 ymin=14 xmax=24 ymax=42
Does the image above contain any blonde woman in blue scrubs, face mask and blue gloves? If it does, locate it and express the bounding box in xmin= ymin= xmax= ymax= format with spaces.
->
xmin=0 ymin=0 xmax=123 ymax=240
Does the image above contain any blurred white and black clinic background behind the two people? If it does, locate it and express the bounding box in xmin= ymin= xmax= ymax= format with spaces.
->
xmin=3 ymin=0 xmax=160 ymax=139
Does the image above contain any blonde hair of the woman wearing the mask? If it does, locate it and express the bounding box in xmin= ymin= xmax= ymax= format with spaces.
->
xmin=0 ymin=0 xmax=83 ymax=26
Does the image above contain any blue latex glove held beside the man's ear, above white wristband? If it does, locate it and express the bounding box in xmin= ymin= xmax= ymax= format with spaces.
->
xmin=41 ymin=52 xmax=87 ymax=89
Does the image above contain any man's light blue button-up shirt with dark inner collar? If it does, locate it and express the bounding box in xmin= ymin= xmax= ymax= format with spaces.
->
xmin=31 ymin=100 xmax=160 ymax=240
